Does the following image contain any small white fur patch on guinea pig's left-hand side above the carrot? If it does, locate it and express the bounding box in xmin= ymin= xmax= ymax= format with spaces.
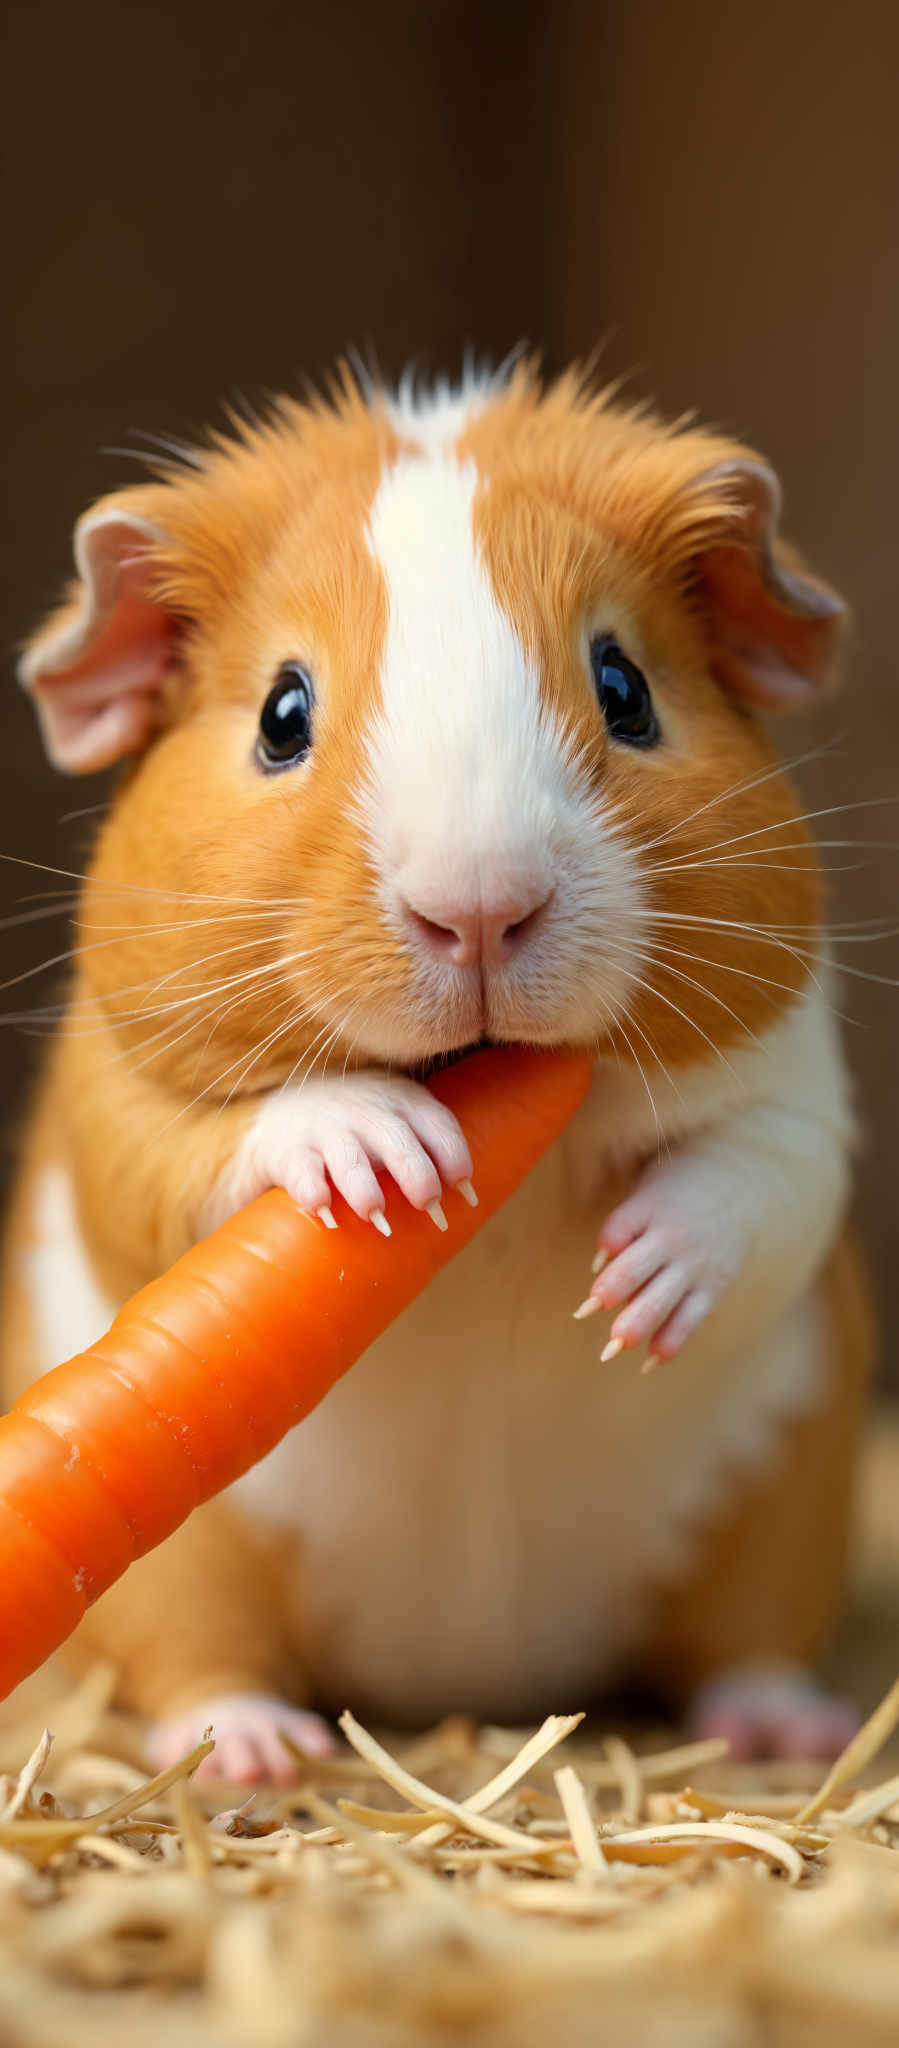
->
xmin=25 ymin=1165 xmax=117 ymax=1372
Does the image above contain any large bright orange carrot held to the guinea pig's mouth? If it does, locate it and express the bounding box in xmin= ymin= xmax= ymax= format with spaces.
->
xmin=0 ymin=1047 xmax=590 ymax=1698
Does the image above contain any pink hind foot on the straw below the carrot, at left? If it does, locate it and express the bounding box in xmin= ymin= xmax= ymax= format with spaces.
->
xmin=147 ymin=1692 xmax=338 ymax=1786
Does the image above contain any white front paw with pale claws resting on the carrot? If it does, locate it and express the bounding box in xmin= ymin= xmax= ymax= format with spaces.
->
xmin=219 ymin=1071 xmax=477 ymax=1237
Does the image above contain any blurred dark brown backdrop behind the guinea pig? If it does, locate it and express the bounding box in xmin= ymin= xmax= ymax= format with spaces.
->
xmin=0 ymin=0 xmax=899 ymax=1380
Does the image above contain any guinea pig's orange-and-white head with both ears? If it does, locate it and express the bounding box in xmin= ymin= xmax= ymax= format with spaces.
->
xmin=23 ymin=369 xmax=844 ymax=1094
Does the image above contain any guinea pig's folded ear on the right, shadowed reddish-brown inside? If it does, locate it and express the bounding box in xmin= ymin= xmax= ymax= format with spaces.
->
xmin=690 ymin=457 xmax=846 ymax=711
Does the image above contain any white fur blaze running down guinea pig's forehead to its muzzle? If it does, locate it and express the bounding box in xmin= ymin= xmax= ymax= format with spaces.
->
xmin=362 ymin=448 xmax=645 ymax=1061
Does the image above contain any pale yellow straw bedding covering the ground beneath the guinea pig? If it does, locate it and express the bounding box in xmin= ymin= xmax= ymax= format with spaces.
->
xmin=0 ymin=1671 xmax=899 ymax=2048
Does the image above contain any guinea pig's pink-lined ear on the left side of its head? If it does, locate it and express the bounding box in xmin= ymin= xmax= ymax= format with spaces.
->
xmin=18 ymin=500 xmax=176 ymax=774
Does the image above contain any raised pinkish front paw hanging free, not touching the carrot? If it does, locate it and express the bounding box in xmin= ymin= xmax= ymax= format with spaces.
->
xmin=575 ymin=1161 xmax=750 ymax=1372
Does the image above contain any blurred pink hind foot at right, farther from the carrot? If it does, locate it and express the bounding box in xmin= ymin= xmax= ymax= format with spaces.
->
xmin=690 ymin=1663 xmax=860 ymax=1761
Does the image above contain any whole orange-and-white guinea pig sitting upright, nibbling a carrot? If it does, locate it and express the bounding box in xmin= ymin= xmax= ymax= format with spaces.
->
xmin=4 ymin=367 xmax=868 ymax=1780
